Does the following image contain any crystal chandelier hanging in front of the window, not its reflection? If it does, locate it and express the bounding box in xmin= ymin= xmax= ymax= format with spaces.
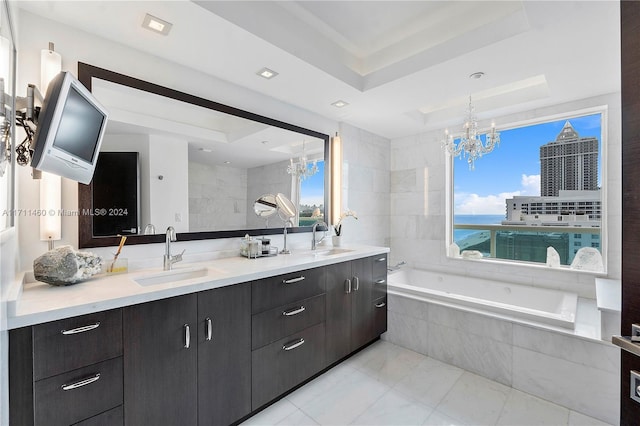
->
xmin=442 ymin=96 xmax=500 ymax=170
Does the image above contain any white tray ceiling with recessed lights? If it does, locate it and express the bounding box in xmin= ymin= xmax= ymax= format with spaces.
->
xmin=18 ymin=0 xmax=620 ymax=138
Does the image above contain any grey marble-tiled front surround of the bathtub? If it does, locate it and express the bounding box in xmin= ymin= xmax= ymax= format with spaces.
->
xmin=383 ymin=272 xmax=620 ymax=424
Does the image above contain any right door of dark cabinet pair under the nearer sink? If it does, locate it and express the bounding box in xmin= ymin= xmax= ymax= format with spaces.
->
xmin=199 ymin=283 xmax=251 ymax=426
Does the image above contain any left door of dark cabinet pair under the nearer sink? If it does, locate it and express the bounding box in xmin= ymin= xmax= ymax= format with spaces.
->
xmin=123 ymin=294 xmax=198 ymax=426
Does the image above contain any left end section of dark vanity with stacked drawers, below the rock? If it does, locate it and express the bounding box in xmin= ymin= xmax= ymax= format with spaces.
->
xmin=9 ymin=309 xmax=123 ymax=426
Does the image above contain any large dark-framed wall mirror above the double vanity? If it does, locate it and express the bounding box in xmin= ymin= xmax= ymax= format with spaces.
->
xmin=78 ymin=63 xmax=329 ymax=248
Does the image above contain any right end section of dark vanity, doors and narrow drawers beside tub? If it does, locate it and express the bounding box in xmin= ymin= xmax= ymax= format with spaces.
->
xmin=326 ymin=255 xmax=387 ymax=364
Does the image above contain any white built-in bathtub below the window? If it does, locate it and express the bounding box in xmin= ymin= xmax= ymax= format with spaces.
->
xmin=387 ymin=269 xmax=578 ymax=329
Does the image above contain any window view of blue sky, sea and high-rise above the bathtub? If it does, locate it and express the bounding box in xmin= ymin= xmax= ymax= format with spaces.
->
xmin=451 ymin=112 xmax=605 ymax=265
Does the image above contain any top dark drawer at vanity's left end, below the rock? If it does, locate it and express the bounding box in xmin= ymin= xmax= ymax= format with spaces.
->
xmin=33 ymin=309 xmax=122 ymax=380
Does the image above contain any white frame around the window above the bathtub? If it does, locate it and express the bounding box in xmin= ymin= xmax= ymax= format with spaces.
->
xmin=444 ymin=105 xmax=609 ymax=276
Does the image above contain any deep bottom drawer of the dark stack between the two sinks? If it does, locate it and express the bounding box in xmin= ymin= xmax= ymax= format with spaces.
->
xmin=251 ymin=323 xmax=325 ymax=410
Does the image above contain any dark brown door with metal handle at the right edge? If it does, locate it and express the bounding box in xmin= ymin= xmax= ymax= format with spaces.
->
xmin=620 ymin=1 xmax=640 ymax=425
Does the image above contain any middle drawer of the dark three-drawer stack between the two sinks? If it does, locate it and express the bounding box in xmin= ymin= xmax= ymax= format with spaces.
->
xmin=251 ymin=294 xmax=325 ymax=349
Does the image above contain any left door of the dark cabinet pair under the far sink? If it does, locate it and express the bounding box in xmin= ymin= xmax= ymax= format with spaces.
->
xmin=325 ymin=262 xmax=353 ymax=365
